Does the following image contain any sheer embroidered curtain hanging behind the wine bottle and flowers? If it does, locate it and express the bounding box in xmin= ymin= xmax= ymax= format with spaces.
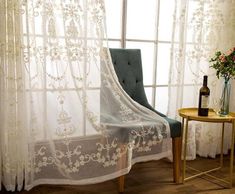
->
xmin=168 ymin=0 xmax=235 ymax=159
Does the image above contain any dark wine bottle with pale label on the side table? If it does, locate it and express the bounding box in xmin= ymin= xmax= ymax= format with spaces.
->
xmin=198 ymin=75 xmax=210 ymax=116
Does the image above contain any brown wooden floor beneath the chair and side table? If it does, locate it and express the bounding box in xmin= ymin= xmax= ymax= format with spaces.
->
xmin=0 ymin=157 xmax=235 ymax=194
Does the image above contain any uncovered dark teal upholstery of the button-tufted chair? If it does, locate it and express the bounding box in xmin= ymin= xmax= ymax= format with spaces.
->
xmin=110 ymin=49 xmax=181 ymax=138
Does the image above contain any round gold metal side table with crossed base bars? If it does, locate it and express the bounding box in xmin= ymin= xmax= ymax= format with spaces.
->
xmin=178 ymin=108 xmax=235 ymax=188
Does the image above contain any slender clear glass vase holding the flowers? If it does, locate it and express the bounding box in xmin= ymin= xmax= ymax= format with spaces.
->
xmin=220 ymin=79 xmax=231 ymax=116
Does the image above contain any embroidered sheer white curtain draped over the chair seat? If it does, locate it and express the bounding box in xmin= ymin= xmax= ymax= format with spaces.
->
xmin=0 ymin=0 xmax=171 ymax=191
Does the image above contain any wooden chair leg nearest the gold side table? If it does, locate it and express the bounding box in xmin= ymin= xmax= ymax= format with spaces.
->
xmin=172 ymin=137 xmax=182 ymax=184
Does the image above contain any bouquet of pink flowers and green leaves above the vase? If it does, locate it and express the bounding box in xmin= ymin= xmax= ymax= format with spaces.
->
xmin=209 ymin=47 xmax=235 ymax=81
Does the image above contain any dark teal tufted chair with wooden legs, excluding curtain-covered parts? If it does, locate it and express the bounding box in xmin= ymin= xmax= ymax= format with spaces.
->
xmin=110 ymin=49 xmax=182 ymax=192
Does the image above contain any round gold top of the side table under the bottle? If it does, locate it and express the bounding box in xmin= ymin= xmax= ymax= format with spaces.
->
xmin=178 ymin=108 xmax=235 ymax=122
